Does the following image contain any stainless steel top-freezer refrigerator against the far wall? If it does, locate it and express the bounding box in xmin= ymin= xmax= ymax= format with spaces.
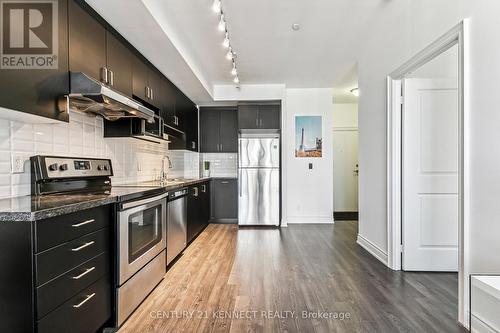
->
xmin=238 ymin=134 xmax=280 ymax=226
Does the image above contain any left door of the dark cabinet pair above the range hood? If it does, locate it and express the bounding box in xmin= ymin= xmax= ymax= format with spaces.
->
xmin=68 ymin=0 xmax=106 ymax=81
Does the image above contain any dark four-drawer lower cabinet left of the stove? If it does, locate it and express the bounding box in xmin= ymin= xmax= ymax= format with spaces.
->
xmin=0 ymin=206 xmax=113 ymax=333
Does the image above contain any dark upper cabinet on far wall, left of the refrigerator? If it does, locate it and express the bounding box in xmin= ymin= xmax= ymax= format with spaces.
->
xmin=200 ymin=107 xmax=238 ymax=153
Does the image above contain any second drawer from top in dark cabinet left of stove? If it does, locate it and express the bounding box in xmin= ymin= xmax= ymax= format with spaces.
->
xmin=35 ymin=228 xmax=109 ymax=286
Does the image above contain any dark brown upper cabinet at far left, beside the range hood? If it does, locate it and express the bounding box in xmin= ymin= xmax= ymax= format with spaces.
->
xmin=0 ymin=0 xmax=69 ymax=121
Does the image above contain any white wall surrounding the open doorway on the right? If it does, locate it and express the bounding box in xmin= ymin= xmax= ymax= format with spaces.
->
xmin=358 ymin=0 xmax=500 ymax=322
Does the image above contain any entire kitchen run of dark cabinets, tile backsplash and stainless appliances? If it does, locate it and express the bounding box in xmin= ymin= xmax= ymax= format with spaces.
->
xmin=0 ymin=0 xmax=281 ymax=332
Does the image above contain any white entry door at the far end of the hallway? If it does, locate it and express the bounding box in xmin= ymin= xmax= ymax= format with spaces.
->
xmin=333 ymin=128 xmax=358 ymax=212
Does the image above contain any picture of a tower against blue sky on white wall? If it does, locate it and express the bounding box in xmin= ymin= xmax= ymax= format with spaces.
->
xmin=295 ymin=116 xmax=323 ymax=157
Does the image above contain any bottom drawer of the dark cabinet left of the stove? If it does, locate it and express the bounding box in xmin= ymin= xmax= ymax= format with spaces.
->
xmin=37 ymin=276 xmax=111 ymax=333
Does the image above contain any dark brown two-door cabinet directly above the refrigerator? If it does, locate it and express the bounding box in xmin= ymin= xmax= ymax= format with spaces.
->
xmin=238 ymin=103 xmax=281 ymax=130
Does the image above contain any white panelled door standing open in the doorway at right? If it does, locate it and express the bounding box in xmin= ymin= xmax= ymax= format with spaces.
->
xmin=402 ymin=79 xmax=460 ymax=271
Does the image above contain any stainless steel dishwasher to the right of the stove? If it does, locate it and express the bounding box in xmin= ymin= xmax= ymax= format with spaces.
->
xmin=167 ymin=188 xmax=187 ymax=265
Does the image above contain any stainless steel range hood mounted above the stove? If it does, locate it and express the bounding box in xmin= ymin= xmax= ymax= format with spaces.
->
xmin=61 ymin=72 xmax=155 ymax=122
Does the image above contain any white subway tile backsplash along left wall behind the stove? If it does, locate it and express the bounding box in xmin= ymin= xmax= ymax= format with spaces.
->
xmin=0 ymin=111 xmax=201 ymax=198
